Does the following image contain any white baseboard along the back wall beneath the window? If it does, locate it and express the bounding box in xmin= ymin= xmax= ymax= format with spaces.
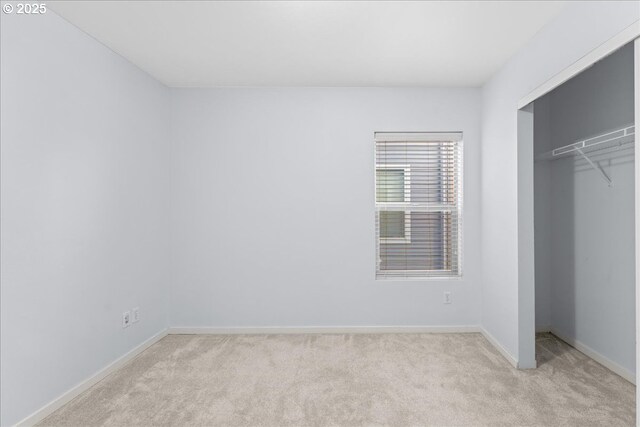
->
xmin=168 ymin=326 xmax=480 ymax=335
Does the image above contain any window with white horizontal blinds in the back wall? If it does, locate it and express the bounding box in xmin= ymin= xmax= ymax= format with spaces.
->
xmin=375 ymin=132 xmax=462 ymax=279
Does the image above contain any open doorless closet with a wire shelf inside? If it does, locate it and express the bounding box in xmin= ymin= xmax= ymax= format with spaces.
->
xmin=518 ymin=42 xmax=636 ymax=384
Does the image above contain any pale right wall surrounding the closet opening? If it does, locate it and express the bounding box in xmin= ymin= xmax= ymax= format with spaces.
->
xmin=481 ymin=1 xmax=640 ymax=367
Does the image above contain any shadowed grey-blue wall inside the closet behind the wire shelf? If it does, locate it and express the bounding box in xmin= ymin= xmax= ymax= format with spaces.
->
xmin=535 ymin=44 xmax=635 ymax=373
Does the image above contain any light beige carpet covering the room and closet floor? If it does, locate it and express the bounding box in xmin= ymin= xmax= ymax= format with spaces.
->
xmin=42 ymin=334 xmax=635 ymax=426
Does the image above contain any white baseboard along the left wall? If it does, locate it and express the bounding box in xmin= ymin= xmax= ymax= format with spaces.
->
xmin=16 ymin=329 xmax=167 ymax=427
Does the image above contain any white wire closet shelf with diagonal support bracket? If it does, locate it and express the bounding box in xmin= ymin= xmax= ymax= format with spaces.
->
xmin=536 ymin=125 xmax=635 ymax=186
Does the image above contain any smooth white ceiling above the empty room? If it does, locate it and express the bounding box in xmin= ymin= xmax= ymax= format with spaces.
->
xmin=47 ymin=1 xmax=564 ymax=87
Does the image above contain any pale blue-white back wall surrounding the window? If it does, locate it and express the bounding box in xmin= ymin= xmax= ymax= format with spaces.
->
xmin=170 ymin=88 xmax=480 ymax=327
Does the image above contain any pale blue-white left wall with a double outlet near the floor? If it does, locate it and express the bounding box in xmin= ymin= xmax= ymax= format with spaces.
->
xmin=0 ymin=11 xmax=169 ymax=425
